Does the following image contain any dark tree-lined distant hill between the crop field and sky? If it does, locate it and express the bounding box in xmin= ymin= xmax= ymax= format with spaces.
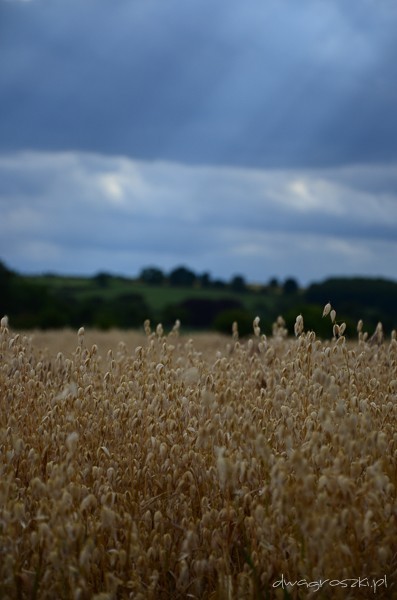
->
xmin=0 ymin=262 xmax=397 ymax=337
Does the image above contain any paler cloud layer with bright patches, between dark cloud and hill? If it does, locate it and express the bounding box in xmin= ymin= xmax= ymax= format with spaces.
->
xmin=0 ymin=153 xmax=397 ymax=284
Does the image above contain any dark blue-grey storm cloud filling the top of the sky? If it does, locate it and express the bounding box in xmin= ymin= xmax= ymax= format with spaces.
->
xmin=0 ymin=0 xmax=397 ymax=167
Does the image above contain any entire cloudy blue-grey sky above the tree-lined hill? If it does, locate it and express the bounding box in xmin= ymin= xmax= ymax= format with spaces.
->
xmin=0 ymin=0 xmax=397 ymax=286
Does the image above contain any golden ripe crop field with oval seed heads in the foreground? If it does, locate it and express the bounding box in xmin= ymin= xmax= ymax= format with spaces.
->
xmin=0 ymin=312 xmax=397 ymax=600
